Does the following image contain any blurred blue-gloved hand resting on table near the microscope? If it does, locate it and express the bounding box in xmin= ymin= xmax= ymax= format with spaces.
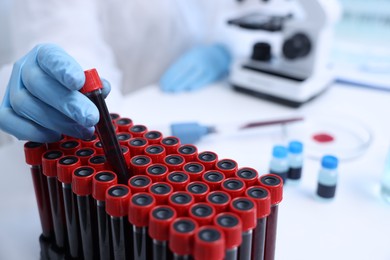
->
xmin=160 ymin=44 xmax=231 ymax=92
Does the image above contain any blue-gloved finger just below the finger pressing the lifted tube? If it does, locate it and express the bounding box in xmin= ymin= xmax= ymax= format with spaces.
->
xmin=8 ymin=85 xmax=94 ymax=138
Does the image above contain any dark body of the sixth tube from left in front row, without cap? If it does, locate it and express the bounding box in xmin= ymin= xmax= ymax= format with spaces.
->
xmin=110 ymin=216 xmax=133 ymax=260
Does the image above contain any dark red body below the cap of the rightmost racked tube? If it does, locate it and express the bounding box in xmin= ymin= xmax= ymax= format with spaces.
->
xmin=264 ymin=204 xmax=279 ymax=260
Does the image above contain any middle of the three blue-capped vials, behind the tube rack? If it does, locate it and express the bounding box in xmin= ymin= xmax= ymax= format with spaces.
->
xmin=287 ymin=141 xmax=303 ymax=181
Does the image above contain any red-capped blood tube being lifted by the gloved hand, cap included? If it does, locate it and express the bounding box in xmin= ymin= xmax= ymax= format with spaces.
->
xmin=80 ymin=69 xmax=130 ymax=183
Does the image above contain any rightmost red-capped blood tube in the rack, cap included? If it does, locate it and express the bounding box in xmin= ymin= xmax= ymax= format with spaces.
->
xmin=260 ymin=174 xmax=283 ymax=260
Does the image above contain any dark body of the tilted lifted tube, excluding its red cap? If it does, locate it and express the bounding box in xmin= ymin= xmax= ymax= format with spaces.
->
xmin=86 ymin=89 xmax=130 ymax=184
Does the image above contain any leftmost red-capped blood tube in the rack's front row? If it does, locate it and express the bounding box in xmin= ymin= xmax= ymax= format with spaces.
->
xmin=24 ymin=142 xmax=53 ymax=246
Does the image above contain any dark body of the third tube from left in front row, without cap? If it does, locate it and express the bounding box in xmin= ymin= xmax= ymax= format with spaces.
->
xmin=62 ymin=183 xmax=83 ymax=258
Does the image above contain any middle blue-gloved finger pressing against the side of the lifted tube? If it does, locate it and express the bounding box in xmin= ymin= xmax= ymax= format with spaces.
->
xmin=20 ymin=54 xmax=99 ymax=127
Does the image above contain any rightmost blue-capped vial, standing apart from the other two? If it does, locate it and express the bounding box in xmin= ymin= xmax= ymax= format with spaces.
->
xmin=317 ymin=155 xmax=339 ymax=199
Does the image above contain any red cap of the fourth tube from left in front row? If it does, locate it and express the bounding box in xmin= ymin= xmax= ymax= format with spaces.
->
xmin=72 ymin=166 xmax=96 ymax=196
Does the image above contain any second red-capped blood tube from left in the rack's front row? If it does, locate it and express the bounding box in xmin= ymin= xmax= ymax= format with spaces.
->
xmin=42 ymin=150 xmax=67 ymax=248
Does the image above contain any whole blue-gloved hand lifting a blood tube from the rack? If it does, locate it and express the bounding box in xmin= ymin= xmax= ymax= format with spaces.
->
xmin=0 ymin=44 xmax=110 ymax=143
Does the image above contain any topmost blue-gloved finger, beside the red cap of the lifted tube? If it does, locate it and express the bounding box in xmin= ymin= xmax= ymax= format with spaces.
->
xmin=31 ymin=44 xmax=85 ymax=90
